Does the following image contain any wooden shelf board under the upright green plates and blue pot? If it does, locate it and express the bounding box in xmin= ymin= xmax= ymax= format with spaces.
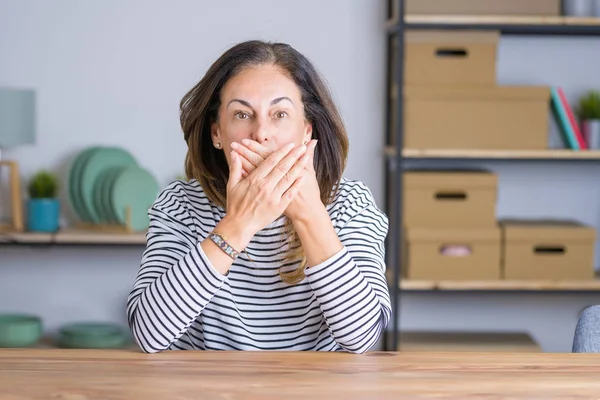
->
xmin=0 ymin=229 xmax=146 ymax=246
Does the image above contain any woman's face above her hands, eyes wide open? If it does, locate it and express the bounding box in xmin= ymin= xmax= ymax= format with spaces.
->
xmin=211 ymin=65 xmax=312 ymax=163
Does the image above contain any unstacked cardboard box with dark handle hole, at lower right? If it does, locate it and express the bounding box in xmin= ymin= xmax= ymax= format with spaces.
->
xmin=500 ymin=220 xmax=596 ymax=280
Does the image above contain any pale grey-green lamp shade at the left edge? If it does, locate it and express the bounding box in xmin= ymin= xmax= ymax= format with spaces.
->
xmin=0 ymin=88 xmax=35 ymax=149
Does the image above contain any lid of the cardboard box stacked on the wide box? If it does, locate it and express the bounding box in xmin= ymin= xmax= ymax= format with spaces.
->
xmin=404 ymin=29 xmax=500 ymax=46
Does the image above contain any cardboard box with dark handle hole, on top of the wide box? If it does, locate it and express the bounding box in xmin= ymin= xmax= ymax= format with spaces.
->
xmin=404 ymin=30 xmax=500 ymax=85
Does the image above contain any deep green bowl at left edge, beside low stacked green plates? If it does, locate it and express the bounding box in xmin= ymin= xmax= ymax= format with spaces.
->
xmin=0 ymin=314 xmax=42 ymax=348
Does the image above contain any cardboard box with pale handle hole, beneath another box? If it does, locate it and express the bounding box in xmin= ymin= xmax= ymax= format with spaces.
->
xmin=402 ymin=227 xmax=501 ymax=281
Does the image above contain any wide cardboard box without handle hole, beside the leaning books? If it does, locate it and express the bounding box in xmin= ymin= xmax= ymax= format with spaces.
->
xmin=404 ymin=85 xmax=550 ymax=150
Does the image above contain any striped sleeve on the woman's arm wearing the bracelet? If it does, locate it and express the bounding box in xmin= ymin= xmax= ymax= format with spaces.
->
xmin=126 ymin=186 xmax=226 ymax=353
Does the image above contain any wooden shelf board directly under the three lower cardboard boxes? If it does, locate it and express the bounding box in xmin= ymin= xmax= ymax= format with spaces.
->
xmin=400 ymin=279 xmax=600 ymax=292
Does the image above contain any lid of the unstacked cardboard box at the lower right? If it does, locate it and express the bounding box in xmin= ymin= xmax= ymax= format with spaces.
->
xmin=498 ymin=219 xmax=596 ymax=242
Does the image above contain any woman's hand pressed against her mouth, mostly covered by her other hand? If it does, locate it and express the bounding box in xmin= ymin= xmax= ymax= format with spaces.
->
xmin=232 ymin=139 xmax=324 ymax=222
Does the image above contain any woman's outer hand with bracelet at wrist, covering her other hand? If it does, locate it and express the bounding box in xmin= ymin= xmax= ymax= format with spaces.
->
xmin=220 ymin=143 xmax=310 ymax=248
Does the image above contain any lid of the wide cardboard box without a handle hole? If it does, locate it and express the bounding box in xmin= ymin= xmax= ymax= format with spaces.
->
xmin=404 ymin=85 xmax=550 ymax=101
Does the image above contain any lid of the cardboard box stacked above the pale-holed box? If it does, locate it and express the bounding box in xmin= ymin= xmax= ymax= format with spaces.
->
xmin=403 ymin=170 xmax=498 ymax=189
